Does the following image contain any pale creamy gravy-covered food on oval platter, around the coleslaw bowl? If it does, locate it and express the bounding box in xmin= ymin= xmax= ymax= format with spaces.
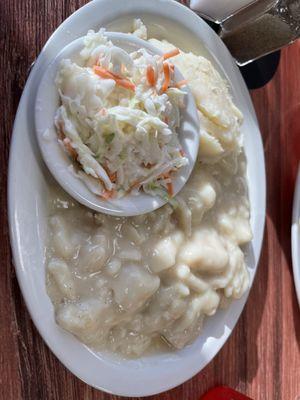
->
xmin=47 ymin=21 xmax=251 ymax=357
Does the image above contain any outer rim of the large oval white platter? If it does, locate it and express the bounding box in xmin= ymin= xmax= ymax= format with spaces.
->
xmin=8 ymin=0 xmax=266 ymax=396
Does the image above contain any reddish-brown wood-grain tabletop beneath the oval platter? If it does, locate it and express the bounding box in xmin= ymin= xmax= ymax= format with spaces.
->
xmin=0 ymin=0 xmax=300 ymax=400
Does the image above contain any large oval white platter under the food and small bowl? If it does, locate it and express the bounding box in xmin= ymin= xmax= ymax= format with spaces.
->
xmin=8 ymin=0 xmax=266 ymax=396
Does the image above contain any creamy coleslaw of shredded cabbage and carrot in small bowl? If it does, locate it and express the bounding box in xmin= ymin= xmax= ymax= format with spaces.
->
xmin=55 ymin=29 xmax=188 ymax=199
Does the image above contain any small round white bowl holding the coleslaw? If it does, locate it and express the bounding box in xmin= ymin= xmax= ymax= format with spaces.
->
xmin=35 ymin=32 xmax=199 ymax=216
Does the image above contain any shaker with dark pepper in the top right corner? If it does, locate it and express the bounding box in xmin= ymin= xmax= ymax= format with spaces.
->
xmin=185 ymin=0 xmax=300 ymax=66
